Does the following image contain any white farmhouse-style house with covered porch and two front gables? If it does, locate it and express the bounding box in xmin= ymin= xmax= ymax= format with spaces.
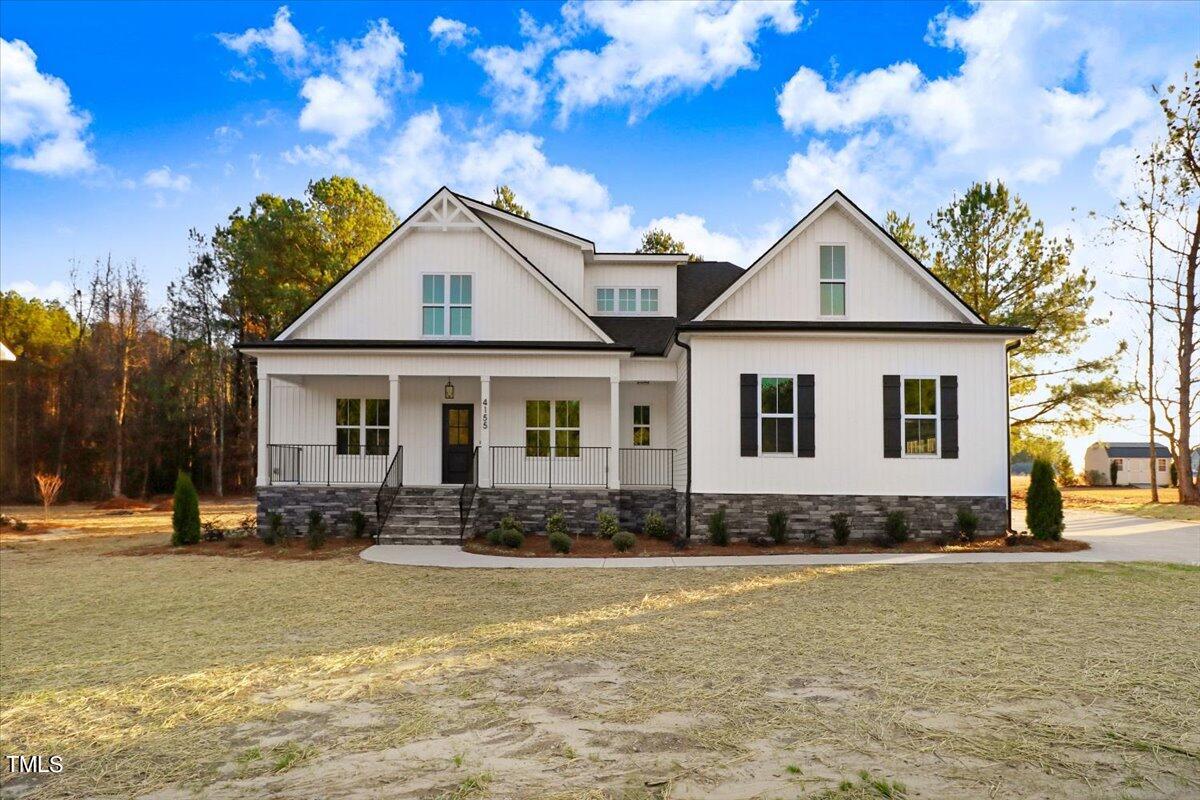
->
xmin=242 ymin=188 xmax=1032 ymax=542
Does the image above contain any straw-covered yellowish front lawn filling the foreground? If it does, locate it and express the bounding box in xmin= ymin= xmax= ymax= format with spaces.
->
xmin=0 ymin=510 xmax=1200 ymax=800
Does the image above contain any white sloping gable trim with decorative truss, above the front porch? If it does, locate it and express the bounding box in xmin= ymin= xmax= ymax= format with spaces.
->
xmin=275 ymin=186 xmax=612 ymax=344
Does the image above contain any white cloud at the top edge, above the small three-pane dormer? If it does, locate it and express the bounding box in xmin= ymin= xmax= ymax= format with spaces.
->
xmin=554 ymin=0 xmax=800 ymax=122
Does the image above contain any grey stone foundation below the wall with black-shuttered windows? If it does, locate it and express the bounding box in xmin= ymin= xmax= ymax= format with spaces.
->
xmin=679 ymin=493 xmax=1008 ymax=540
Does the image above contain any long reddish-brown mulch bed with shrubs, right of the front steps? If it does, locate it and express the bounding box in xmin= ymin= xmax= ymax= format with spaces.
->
xmin=463 ymin=534 xmax=1090 ymax=558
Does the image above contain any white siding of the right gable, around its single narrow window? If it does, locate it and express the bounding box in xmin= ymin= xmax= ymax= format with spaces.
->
xmin=709 ymin=209 xmax=964 ymax=321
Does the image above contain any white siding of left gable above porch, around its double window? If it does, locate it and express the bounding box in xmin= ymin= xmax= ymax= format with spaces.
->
xmin=292 ymin=229 xmax=600 ymax=342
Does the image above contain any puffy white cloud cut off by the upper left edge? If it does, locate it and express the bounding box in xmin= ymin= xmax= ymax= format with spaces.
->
xmin=0 ymin=38 xmax=96 ymax=175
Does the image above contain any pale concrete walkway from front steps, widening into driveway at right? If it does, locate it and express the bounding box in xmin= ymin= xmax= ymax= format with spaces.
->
xmin=362 ymin=510 xmax=1200 ymax=570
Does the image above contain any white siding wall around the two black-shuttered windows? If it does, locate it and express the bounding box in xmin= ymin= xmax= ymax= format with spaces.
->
xmin=691 ymin=335 xmax=1008 ymax=497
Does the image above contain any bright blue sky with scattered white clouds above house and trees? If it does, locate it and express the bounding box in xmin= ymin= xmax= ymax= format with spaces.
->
xmin=0 ymin=2 xmax=1200 ymax=462
